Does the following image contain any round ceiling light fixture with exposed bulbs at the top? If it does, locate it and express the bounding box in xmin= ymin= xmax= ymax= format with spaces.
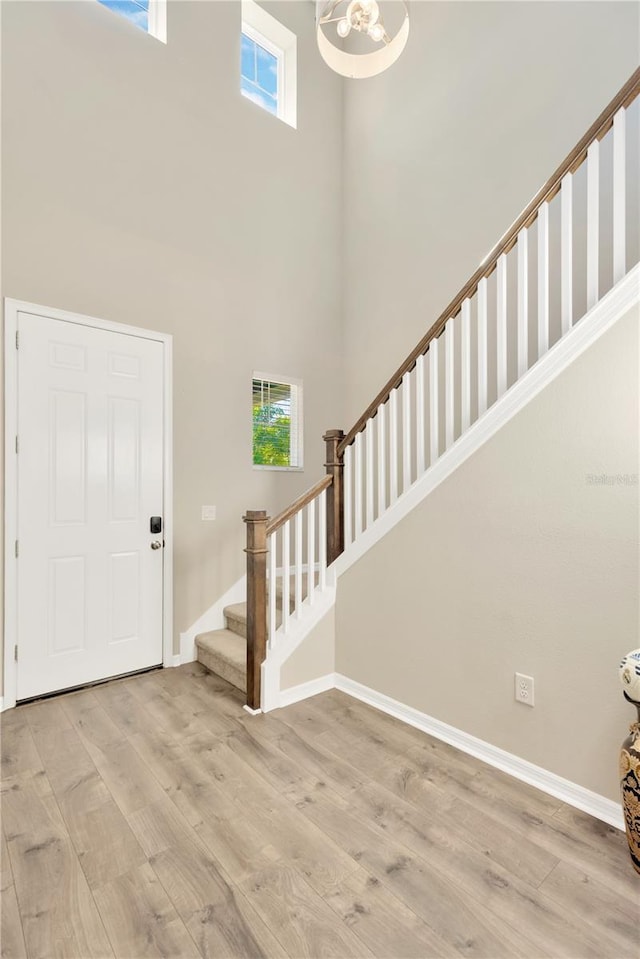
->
xmin=317 ymin=0 xmax=409 ymax=79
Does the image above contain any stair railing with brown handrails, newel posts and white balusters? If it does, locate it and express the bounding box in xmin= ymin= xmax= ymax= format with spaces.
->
xmin=245 ymin=69 xmax=640 ymax=709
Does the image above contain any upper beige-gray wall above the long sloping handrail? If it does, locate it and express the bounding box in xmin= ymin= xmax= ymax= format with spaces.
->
xmin=344 ymin=0 xmax=640 ymax=427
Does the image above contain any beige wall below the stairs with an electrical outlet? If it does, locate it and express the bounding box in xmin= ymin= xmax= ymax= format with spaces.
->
xmin=336 ymin=306 xmax=640 ymax=800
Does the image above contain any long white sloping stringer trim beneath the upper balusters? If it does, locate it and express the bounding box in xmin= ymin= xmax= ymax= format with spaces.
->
xmin=334 ymin=264 xmax=640 ymax=578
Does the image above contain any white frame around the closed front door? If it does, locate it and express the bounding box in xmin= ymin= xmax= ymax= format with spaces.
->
xmin=2 ymin=298 xmax=175 ymax=709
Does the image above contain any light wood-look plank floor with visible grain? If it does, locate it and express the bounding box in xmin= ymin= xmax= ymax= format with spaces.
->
xmin=1 ymin=664 xmax=640 ymax=959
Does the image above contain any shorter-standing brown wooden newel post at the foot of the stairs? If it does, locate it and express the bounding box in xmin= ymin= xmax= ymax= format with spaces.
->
xmin=242 ymin=509 xmax=268 ymax=709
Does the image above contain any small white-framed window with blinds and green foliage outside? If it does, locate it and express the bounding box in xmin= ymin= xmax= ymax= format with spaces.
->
xmin=251 ymin=373 xmax=303 ymax=470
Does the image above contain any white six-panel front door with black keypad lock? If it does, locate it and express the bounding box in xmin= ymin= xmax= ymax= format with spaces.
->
xmin=17 ymin=313 xmax=164 ymax=700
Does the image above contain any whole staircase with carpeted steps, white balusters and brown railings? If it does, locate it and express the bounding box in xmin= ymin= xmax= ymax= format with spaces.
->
xmin=196 ymin=69 xmax=640 ymax=711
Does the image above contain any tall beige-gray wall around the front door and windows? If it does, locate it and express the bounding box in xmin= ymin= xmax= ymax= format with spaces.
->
xmin=2 ymin=0 xmax=343 ymax=660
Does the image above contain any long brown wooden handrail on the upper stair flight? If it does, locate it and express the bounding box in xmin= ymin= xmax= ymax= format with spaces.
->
xmin=338 ymin=67 xmax=640 ymax=455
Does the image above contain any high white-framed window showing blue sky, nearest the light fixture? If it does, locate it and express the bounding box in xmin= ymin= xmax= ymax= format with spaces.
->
xmin=240 ymin=0 xmax=297 ymax=127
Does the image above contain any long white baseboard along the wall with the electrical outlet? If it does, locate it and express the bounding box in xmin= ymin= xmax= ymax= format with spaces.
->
xmin=332 ymin=673 xmax=624 ymax=830
